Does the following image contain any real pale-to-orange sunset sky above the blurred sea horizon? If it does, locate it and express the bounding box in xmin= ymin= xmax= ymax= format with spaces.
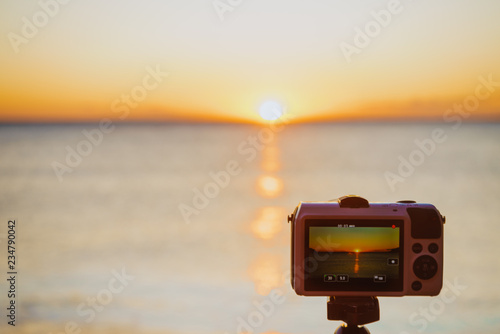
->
xmin=0 ymin=0 xmax=500 ymax=122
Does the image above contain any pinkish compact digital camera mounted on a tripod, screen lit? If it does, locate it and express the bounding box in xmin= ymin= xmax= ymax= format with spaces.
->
xmin=288 ymin=195 xmax=445 ymax=296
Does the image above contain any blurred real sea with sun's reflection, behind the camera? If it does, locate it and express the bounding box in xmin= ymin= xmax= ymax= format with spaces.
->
xmin=0 ymin=123 xmax=500 ymax=334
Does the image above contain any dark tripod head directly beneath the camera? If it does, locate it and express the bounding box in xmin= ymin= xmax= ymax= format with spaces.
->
xmin=326 ymin=296 xmax=380 ymax=334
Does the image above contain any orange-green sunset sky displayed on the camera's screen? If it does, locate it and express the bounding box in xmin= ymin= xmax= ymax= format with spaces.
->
xmin=309 ymin=226 xmax=399 ymax=252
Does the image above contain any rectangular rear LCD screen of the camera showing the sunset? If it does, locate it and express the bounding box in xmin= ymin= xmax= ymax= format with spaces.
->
xmin=304 ymin=219 xmax=404 ymax=291
